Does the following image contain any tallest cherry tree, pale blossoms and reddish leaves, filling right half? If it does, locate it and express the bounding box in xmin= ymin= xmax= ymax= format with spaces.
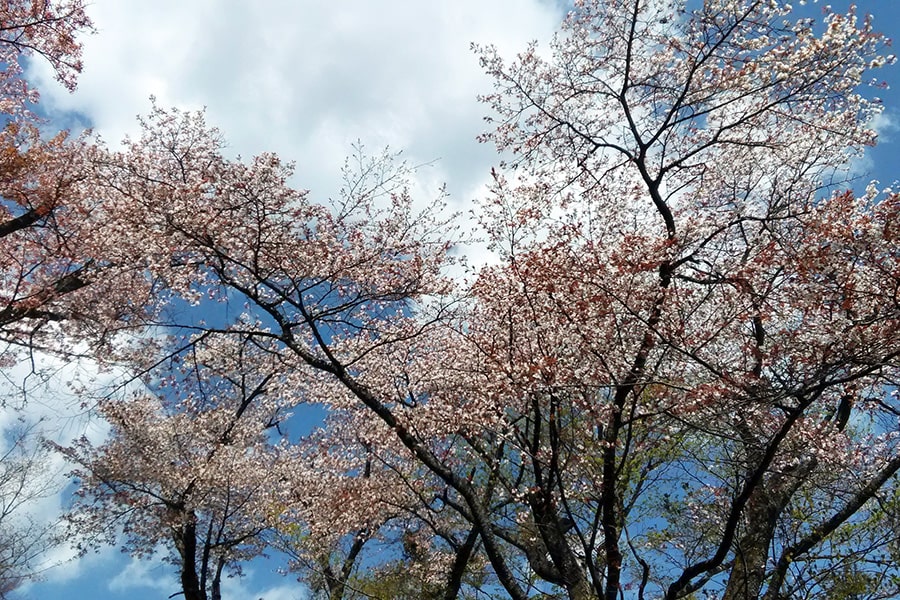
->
xmin=464 ymin=1 xmax=900 ymax=598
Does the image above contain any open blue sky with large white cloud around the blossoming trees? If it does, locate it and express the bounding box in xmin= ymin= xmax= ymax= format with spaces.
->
xmin=10 ymin=0 xmax=900 ymax=600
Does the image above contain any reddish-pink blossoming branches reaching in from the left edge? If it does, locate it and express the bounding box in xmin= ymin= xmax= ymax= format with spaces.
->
xmin=0 ymin=0 xmax=154 ymax=364
